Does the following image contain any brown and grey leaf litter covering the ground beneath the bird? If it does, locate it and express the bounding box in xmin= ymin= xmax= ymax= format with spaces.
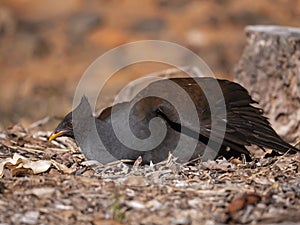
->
xmin=0 ymin=125 xmax=300 ymax=225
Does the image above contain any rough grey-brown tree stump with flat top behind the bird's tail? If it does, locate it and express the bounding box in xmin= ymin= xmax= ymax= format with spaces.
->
xmin=235 ymin=26 xmax=300 ymax=142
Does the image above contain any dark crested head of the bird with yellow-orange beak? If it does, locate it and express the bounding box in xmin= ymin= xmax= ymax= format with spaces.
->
xmin=49 ymin=96 xmax=92 ymax=141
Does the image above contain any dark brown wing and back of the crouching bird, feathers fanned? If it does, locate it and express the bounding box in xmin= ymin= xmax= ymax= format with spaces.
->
xmin=98 ymin=78 xmax=299 ymax=158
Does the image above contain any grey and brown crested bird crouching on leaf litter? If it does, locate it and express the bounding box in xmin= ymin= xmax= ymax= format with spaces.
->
xmin=49 ymin=77 xmax=300 ymax=164
